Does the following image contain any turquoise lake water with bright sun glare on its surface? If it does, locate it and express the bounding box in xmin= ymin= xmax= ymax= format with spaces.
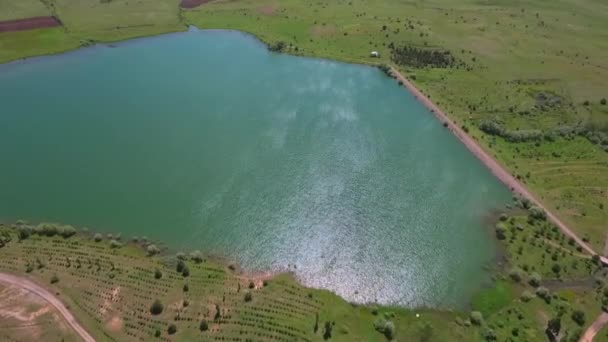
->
xmin=0 ymin=30 xmax=510 ymax=307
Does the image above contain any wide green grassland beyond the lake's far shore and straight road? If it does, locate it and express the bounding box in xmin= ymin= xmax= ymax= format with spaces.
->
xmin=0 ymin=0 xmax=608 ymax=252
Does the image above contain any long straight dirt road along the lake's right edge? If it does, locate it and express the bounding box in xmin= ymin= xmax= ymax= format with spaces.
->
xmin=391 ymin=66 xmax=608 ymax=265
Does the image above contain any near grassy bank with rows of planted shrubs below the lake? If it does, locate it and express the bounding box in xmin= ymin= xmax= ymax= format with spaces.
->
xmin=0 ymin=209 xmax=608 ymax=341
